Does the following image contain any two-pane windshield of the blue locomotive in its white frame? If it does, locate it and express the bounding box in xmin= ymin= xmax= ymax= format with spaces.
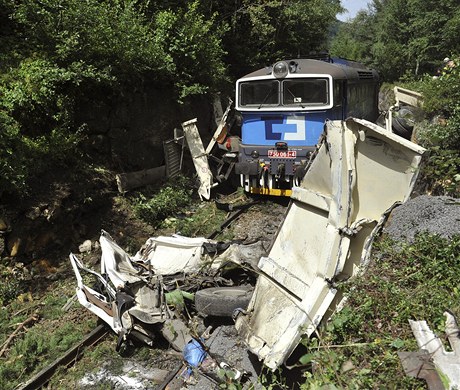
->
xmin=239 ymin=78 xmax=330 ymax=108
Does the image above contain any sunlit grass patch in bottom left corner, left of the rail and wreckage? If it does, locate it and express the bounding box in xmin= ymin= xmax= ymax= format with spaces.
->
xmin=0 ymin=281 xmax=96 ymax=390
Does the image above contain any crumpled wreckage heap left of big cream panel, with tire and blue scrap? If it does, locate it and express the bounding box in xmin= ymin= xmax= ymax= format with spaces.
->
xmin=70 ymin=231 xmax=264 ymax=384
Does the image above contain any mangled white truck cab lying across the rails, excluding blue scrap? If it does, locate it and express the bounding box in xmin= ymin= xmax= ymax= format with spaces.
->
xmin=69 ymin=231 xmax=263 ymax=351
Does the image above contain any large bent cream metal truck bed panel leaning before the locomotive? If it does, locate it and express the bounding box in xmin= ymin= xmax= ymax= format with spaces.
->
xmin=236 ymin=118 xmax=425 ymax=369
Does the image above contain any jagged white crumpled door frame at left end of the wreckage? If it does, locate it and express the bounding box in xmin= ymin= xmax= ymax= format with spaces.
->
xmin=69 ymin=231 xmax=172 ymax=338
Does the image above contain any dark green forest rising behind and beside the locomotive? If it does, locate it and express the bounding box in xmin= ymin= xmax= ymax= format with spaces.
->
xmin=0 ymin=0 xmax=460 ymax=196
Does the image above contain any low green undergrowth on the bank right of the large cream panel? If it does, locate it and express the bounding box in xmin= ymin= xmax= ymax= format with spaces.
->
xmin=300 ymin=234 xmax=460 ymax=389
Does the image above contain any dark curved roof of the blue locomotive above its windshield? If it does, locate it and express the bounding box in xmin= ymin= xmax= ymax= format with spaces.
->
xmin=240 ymin=58 xmax=378 ymax=80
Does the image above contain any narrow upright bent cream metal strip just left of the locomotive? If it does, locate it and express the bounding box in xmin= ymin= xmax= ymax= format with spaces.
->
xmin=182 ymin=118 xmax=213 ymax=200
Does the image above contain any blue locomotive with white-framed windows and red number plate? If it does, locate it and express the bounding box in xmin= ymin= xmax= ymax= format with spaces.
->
xmin=235 ymin=59 xmax=378 ymax=196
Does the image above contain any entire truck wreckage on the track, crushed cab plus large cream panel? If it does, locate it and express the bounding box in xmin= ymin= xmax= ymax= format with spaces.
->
xmin=70 ymin=118 xmax=425 ymax=384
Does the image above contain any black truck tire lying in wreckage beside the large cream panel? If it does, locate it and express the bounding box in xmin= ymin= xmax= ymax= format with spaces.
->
xmin=195 ymin=286 xmax=253 ymax=317
